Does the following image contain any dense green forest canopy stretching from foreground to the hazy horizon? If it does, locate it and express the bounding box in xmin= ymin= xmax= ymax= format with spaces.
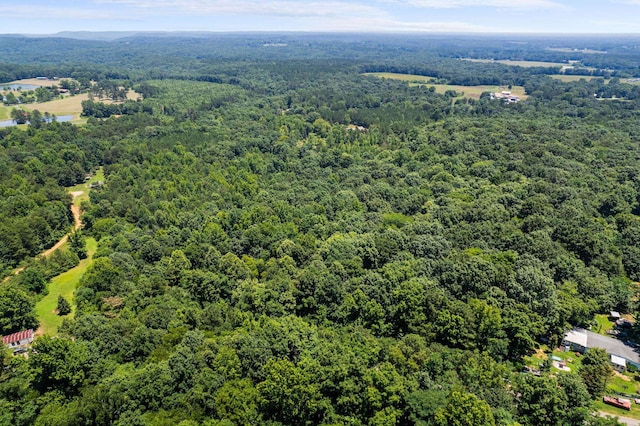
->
xmin=0 ymin=34 xmax=640 ymax=426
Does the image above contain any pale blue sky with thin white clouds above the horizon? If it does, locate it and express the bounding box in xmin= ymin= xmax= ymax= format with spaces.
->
xmin=0 ymin=0 xmax=640 ymax=34
